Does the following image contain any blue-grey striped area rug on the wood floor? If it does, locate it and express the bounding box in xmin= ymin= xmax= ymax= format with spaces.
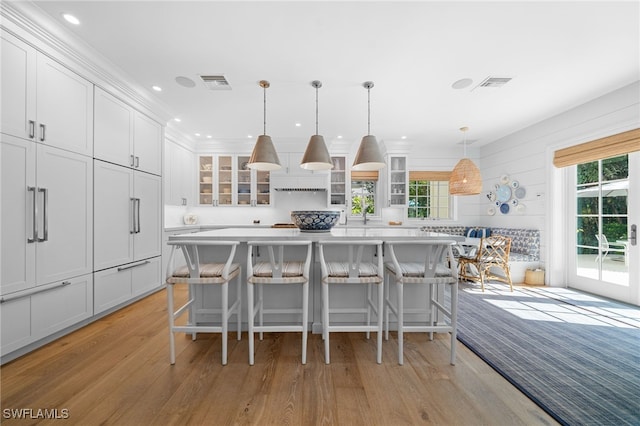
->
xmin=458 ymin=283 xmax=640 ymax=425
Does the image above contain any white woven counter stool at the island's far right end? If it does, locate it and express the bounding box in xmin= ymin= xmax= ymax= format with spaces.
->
xmin=384 ymin=240 xmax=458 ymax=365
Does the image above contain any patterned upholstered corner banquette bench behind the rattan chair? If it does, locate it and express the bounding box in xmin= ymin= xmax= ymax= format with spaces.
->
xmin=421 ymin=225 xmax=540 ymax=283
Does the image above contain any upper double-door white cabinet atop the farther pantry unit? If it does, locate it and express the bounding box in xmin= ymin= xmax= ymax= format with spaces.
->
xmin=94 ymin=87 xmax=162 ymax=175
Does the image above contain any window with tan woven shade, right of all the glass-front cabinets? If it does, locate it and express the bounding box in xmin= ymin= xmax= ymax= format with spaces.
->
xmin=407 ymin=171 xmax=453 ymax=219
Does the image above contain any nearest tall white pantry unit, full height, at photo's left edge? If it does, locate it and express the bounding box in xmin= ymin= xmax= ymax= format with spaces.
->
xmin=0 ymin=31 xmax=93 ymax=356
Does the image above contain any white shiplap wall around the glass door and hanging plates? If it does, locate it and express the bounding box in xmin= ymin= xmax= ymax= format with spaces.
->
xmin=478 ymin=82 xmax=640 ymax=286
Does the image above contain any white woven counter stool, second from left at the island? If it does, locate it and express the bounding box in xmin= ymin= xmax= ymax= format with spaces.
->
xmin=247 ymin=240 xmax=311 ymax=365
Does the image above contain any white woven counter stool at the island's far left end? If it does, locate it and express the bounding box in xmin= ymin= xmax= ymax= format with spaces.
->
xmin=167 ymin=240 xmax=242 ymax=365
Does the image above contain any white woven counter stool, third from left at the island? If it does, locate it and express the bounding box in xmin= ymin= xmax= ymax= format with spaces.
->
xmin=318 ymin=240 xmax=384 ymax=364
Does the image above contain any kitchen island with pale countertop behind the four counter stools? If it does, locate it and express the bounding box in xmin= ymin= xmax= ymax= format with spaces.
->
xmin=169 ymin=226 xmax=465 ymax=333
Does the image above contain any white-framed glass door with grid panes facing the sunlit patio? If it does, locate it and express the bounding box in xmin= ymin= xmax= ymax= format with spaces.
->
xmin=567 ymin=152 xmax=640 ymax=304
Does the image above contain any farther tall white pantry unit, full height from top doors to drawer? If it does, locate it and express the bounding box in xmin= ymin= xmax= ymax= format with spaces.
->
xmin=94 ymin=87 xmax=162 ymax=314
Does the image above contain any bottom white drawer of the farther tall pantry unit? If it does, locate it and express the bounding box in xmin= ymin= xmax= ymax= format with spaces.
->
xmin=93 ymin=256 xmax=162 ymax=314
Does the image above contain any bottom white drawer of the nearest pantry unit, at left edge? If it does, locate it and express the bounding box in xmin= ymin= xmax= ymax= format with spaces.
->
xmin=0 ymin=274 xmax=93 ymax=356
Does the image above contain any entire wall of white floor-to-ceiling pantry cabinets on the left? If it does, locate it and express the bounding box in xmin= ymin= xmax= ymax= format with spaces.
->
xmin=0 ymin=26 xmax=164 ymax=362
